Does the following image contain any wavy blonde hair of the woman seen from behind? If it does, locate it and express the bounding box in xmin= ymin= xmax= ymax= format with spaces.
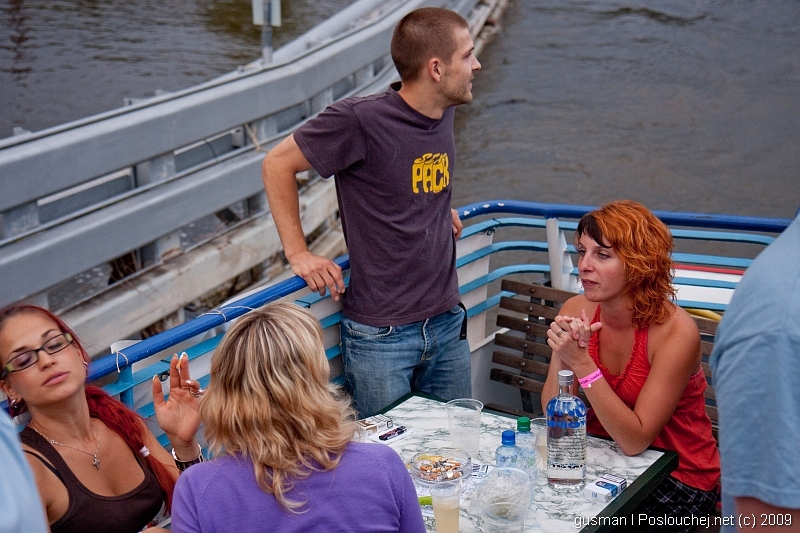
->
xmin=200 ymin=303 xmax=356 ymax=512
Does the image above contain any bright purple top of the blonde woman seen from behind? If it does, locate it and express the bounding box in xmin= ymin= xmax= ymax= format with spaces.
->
xmin=172 ymin=442 xmax=425 ymax=533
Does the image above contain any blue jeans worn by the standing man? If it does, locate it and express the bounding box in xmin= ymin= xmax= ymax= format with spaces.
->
xmin=341 ymin=306 xmax=472 ymax=418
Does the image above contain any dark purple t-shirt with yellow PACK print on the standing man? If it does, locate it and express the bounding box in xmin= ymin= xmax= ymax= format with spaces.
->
xmin=294 ymin=84 xmax=461 ymax=327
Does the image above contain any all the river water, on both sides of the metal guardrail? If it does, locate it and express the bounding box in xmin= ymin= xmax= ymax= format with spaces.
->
xmin=0 ymin=0 xmax=800 ymax=218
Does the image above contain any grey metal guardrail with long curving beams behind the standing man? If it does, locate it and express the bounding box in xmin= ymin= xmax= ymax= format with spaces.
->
xmin=0 ymin=0 xmax=482 ymax=304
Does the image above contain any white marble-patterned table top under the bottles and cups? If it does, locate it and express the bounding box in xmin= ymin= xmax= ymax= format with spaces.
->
xmin=385 ymin=396 xmax=663 ymax=533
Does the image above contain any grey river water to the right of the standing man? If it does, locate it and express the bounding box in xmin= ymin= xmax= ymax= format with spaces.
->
xmin=455 ymin=0 xmax=800 ymax=218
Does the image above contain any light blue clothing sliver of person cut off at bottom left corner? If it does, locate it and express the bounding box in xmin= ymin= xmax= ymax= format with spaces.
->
xmin=0 ymin=413 xmax=50 ymax=533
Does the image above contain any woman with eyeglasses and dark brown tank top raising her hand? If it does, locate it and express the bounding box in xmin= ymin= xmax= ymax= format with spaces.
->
xmin=0 ymin=305 xmax=202 ymax=533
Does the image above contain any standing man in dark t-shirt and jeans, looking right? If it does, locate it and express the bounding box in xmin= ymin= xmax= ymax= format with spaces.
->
xmin=262 ymin=8 xmax=481 ymax=417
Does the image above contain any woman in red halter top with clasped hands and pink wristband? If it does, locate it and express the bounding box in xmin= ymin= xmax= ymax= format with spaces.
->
xmin=542 ymin=201 xmax=720 ymax=531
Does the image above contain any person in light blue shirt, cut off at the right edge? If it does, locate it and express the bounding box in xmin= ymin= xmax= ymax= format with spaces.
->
xmin=710 ymin=214 xmax=800 ymax=532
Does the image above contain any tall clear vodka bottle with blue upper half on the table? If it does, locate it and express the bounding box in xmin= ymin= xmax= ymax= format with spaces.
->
xmin=547 ymin=370 xmax=586 ymax=491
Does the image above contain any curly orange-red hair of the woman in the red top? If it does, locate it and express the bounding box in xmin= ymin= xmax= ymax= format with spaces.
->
xmin=575 ymin=200 xmax=676 ymax=328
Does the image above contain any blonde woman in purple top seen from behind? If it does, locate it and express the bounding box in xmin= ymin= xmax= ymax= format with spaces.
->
xmin=172 ymin=303 xmax=425 ymax=533
